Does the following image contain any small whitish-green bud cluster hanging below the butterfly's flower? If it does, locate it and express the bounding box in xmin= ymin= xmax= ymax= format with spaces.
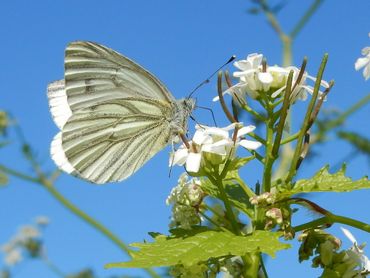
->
xmin=166 ymin=173 xmax=204 ymax=229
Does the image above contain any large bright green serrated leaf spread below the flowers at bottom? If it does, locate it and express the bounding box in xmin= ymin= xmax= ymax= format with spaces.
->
xmin=105 ymin=229 xmax=290 ymax=268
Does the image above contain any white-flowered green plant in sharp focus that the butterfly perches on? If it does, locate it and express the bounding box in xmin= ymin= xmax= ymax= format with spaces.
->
xmin=107 ymin=54 xmax=370 ymax=277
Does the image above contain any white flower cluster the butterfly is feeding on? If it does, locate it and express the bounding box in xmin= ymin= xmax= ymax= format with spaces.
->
xmin=170 ymin=123 xmax=261 ymax=173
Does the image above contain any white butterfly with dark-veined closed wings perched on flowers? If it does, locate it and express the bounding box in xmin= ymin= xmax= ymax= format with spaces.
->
xmin=48 ymin=41 xmax=195 ymax=184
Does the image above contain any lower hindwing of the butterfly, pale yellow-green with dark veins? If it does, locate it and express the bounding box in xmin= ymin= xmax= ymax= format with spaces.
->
xmin=62 ymin=99 xmax=171 ymax=183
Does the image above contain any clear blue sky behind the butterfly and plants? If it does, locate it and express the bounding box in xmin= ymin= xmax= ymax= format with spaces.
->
xmin=0 ymin=0 xmax=370 ymax=278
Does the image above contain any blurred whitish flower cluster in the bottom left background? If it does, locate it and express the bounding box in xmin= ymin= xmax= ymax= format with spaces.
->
xmin=0 ymin=216 xmax=49 ymax=266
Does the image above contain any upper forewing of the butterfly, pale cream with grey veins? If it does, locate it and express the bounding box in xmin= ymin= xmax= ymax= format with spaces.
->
xmin=64 ymin=41 xmax=175 ymax=111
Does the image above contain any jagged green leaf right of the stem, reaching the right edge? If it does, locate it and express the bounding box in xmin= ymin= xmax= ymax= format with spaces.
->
xmin=278 ymin=165 xmax=370 ymax=199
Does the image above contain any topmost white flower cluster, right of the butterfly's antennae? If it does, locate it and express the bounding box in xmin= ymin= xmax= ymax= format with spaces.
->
xmin=214 ymin=53 xmax=329 ymax=102
